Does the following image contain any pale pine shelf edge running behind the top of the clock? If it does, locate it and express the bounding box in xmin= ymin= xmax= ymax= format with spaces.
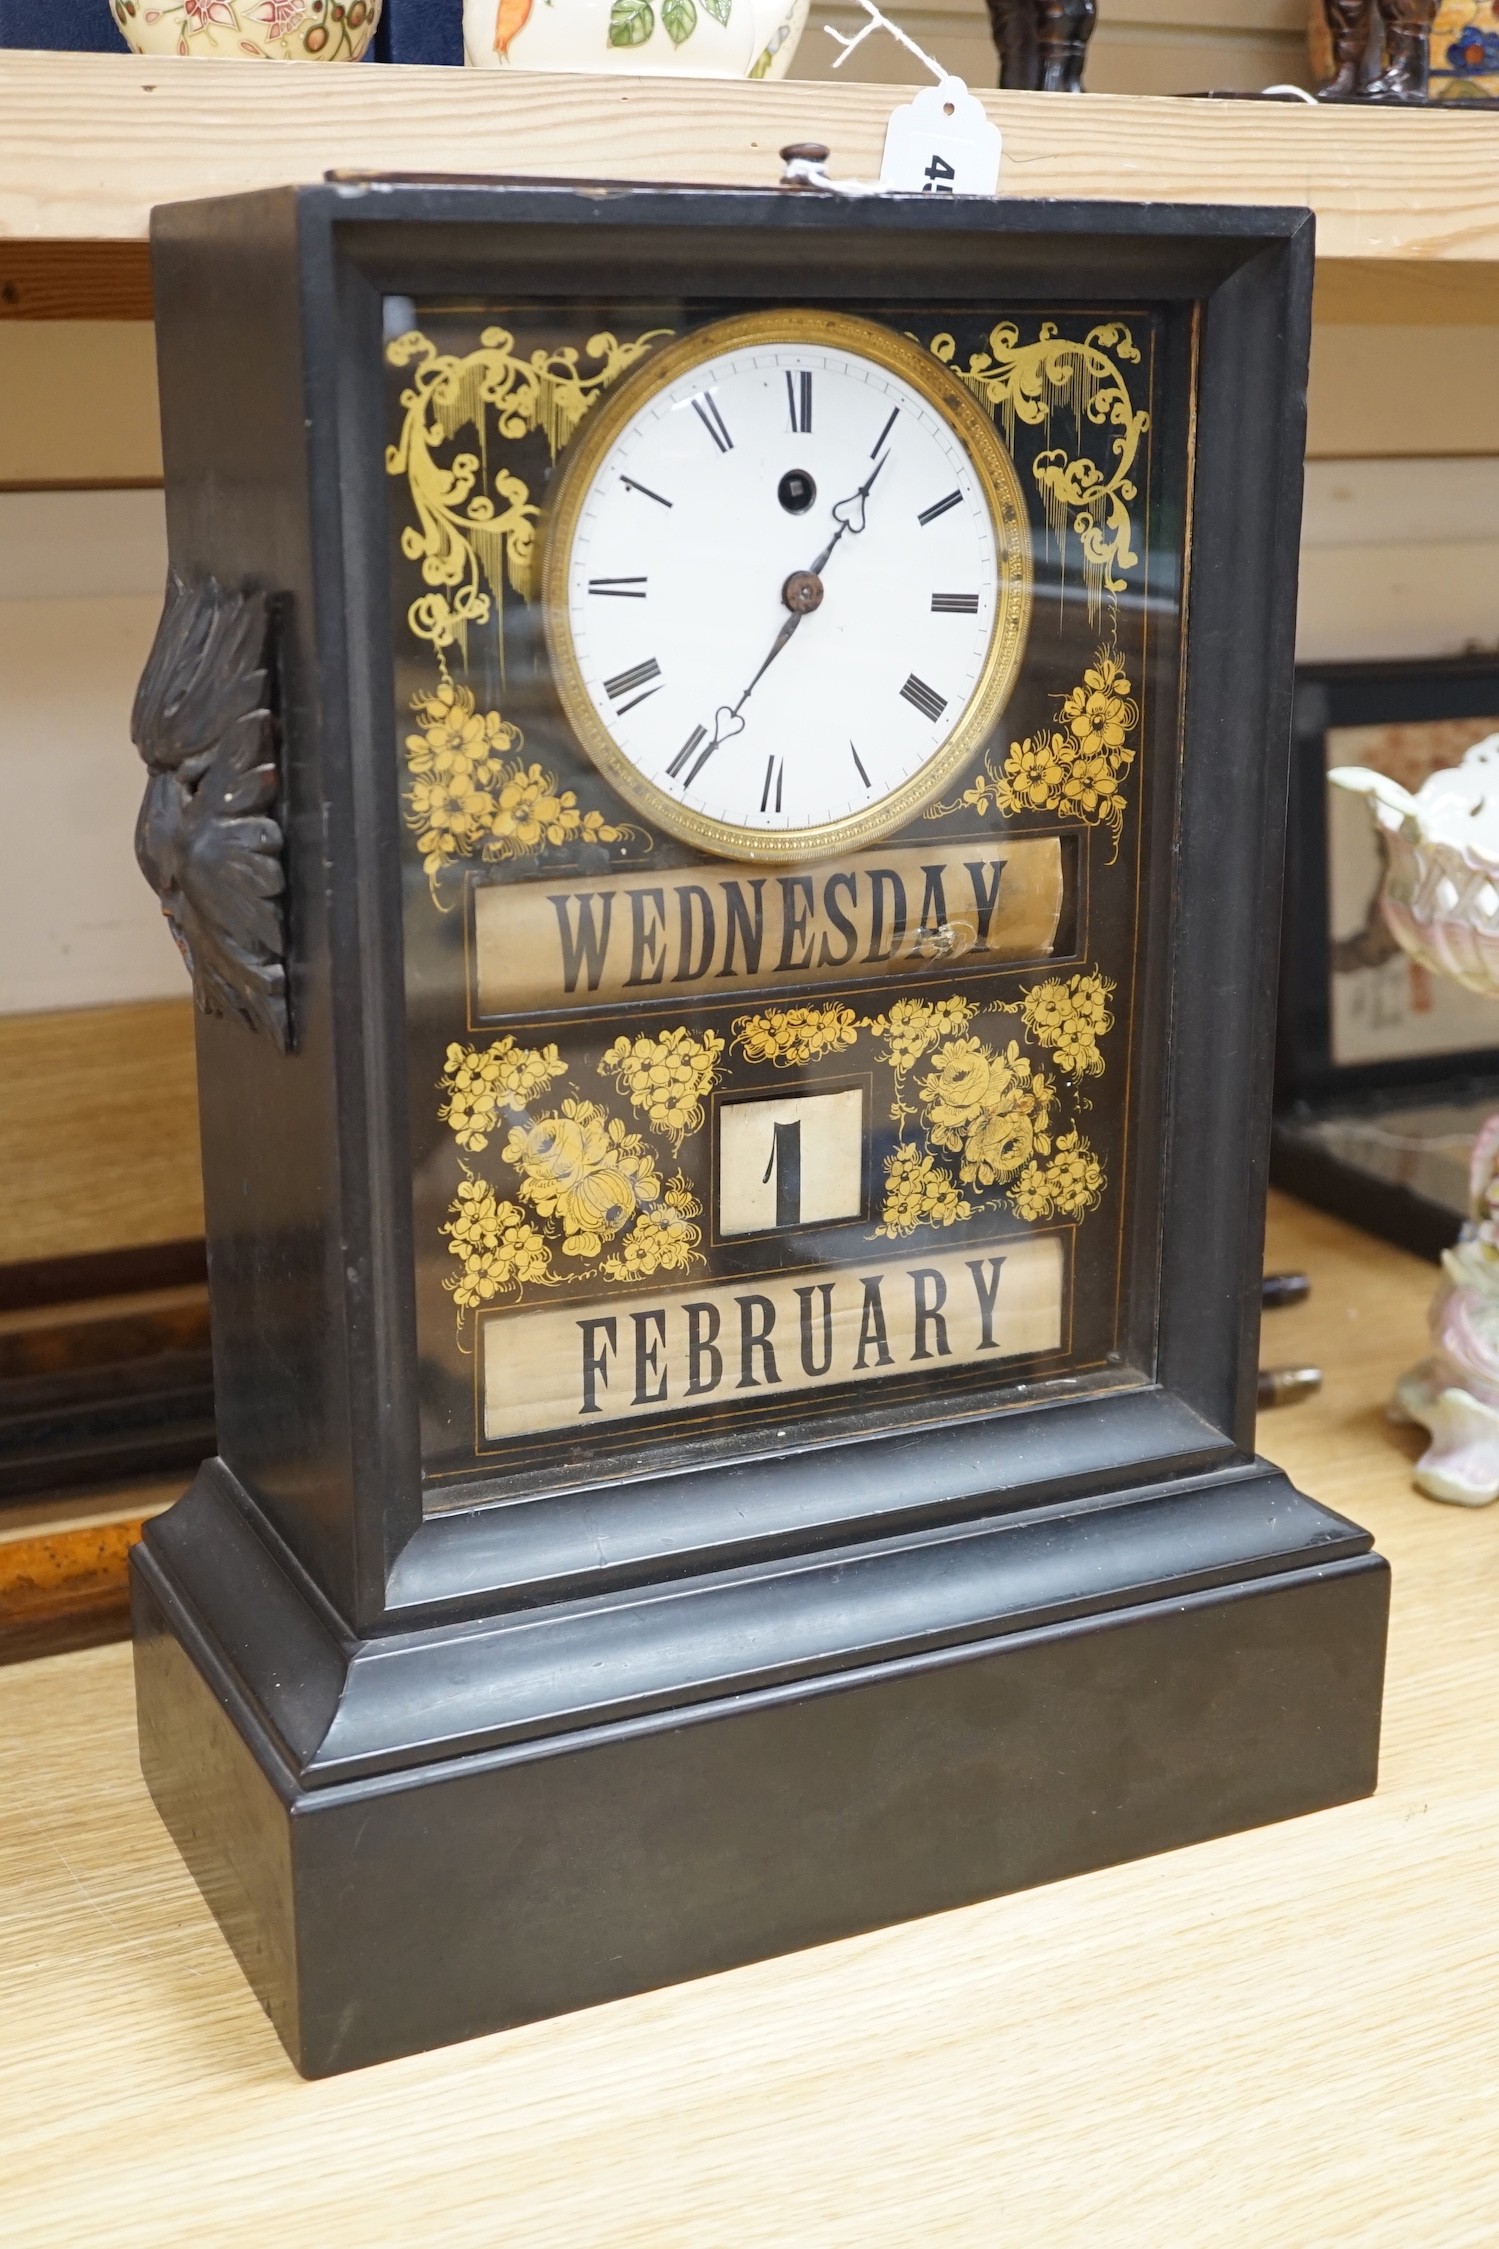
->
xmin=0 ymin=49 xmax=1499 ymax=269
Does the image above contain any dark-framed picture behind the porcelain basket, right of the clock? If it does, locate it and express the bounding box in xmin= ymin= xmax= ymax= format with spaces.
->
xmin=1272 ymin=657 xmax=1499 ymax=1255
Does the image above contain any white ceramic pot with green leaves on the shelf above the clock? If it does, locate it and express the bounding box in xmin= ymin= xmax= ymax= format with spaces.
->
xmin=463 ymin=0 xmax=811 ymax=79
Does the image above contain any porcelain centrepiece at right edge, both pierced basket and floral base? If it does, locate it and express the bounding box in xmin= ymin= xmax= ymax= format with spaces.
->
xmin=1328 ymin=733 xmax=1499 ymax=1507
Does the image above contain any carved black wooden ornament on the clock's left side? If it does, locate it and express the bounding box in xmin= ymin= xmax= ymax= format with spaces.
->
xmin=130 ymin=571 xmax=292 ymax=1055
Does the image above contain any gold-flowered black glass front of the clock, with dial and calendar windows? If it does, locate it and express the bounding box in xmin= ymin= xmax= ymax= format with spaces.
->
xmin=387 ymin=285 xmax=1191 ymax=1507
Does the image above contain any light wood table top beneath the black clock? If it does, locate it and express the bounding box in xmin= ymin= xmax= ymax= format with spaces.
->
xmin=0 ymin=1201 xmax=1499 ymax=2249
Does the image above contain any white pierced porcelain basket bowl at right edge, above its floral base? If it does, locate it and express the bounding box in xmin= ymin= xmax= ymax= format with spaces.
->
xmin=1328 ymin=733 xmax=1499 ymax=999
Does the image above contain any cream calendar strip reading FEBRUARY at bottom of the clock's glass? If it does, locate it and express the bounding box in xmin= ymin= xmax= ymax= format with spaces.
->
xmin=481 ymin=1235 xmax=1065 ymax=1444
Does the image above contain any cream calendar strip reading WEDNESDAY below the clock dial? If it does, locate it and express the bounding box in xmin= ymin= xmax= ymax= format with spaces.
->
xmin=472 ymin=837 xmax=1074 ymax=1017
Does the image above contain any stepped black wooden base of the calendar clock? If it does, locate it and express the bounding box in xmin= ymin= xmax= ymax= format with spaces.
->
xmin=135 ymin=1462 xmax=1389 ymax=2076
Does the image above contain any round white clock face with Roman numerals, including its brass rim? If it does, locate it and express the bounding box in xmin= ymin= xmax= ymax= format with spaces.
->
xmin=546 ymin=313 xmax=1029 ymax=859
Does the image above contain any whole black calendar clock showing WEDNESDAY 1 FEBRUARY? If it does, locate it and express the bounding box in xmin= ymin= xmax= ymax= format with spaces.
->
xmin=135 ymin=180 xmax=1387 ymax=2074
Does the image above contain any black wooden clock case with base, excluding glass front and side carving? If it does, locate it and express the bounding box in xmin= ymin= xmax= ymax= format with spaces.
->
xmin=135 ymin=180 xmax=1389 ymax=2076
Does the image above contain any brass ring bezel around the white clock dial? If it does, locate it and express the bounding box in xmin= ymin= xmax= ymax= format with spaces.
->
xmin=542 ymin=310 xmax=1032 ymax=861
